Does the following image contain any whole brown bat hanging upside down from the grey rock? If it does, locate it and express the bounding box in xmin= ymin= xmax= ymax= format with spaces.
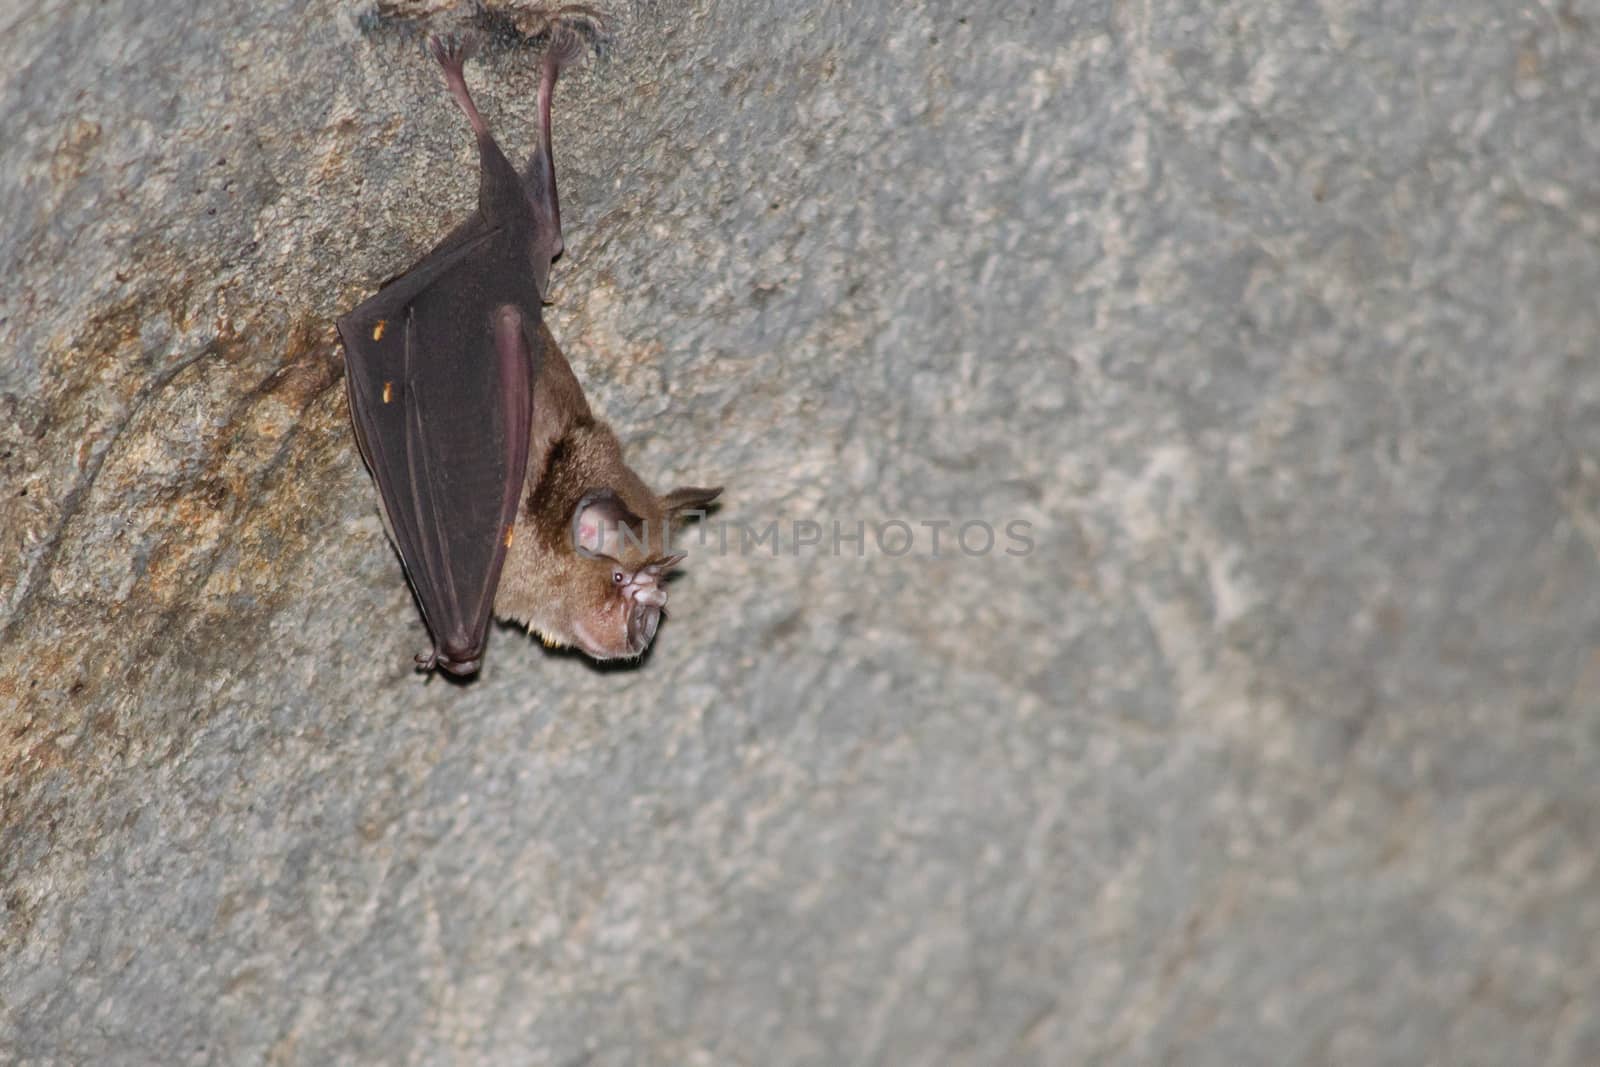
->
xmin=338 ymin=31 xmax=720 ymax=675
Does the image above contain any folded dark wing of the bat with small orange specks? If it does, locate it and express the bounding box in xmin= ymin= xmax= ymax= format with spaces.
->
xmin=339 ymin=226 xmax=539 ymax=673
